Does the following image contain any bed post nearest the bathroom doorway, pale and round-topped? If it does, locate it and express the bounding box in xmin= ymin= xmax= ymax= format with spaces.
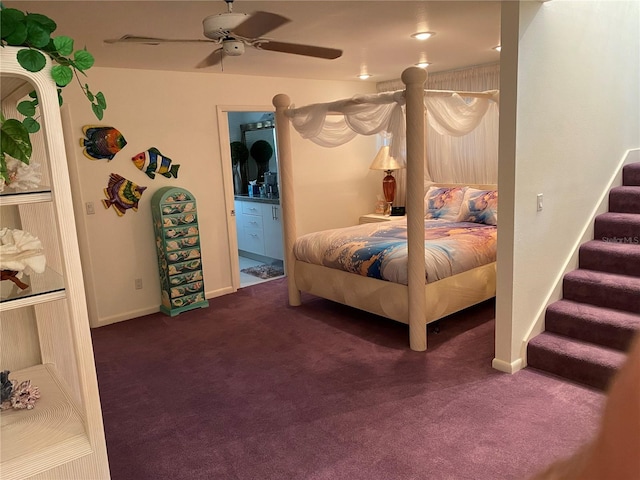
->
xmin=272 ymin=93 xmax=302 ymax=306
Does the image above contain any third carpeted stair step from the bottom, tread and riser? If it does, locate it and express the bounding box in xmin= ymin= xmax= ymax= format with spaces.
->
xmin=562 ymin=268 xmax=640 ymax=313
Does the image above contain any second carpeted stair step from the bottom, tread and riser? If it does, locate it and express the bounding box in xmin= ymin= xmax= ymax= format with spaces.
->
xmin=545 ymin=299 xmax=640 ymax=351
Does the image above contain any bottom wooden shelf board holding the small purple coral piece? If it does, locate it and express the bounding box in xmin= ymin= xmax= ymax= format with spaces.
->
xmin=0 ymin=364 xmax=92 ymax=480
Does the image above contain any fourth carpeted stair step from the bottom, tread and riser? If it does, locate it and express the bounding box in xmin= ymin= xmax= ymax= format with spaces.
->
xmin=578 ymin=240 xmax=640 ymax=276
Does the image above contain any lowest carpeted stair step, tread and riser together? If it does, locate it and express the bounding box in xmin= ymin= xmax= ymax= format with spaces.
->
xmin=527 ymin=332 xmax=627 ymax=390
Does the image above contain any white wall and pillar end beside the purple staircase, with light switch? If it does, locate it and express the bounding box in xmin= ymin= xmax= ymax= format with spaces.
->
xmin=494 ymin=0 xmax=640 ymax=371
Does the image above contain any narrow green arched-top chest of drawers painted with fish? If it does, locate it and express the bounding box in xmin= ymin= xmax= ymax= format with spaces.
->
xmin=151 ymin=187 xmax=209 ymax=316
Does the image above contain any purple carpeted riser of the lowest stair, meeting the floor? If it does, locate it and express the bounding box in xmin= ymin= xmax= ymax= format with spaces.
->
xmin=527 ymin=345 xmax=617 ymax=390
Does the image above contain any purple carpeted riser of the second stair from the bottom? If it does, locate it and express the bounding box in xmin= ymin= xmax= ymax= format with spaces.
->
xmin=545 ymin=309 xmax=640 ymax=351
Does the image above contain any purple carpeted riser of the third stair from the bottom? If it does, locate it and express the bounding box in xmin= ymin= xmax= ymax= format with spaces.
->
xmin=562 ymin=277 xmax=640 ymax=313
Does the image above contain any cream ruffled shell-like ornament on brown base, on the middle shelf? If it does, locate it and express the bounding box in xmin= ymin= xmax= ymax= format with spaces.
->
xmin=0 ymin=228 xmax=47 ymax=290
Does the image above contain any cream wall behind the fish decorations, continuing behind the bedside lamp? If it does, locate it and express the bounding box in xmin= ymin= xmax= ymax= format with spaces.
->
xmin=63 ymin=68 xmax=380 ymax=326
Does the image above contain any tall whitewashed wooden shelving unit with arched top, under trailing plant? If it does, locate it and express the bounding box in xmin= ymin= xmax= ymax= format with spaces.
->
xmin=0 ymin=46 xmax=110 ymax=480
